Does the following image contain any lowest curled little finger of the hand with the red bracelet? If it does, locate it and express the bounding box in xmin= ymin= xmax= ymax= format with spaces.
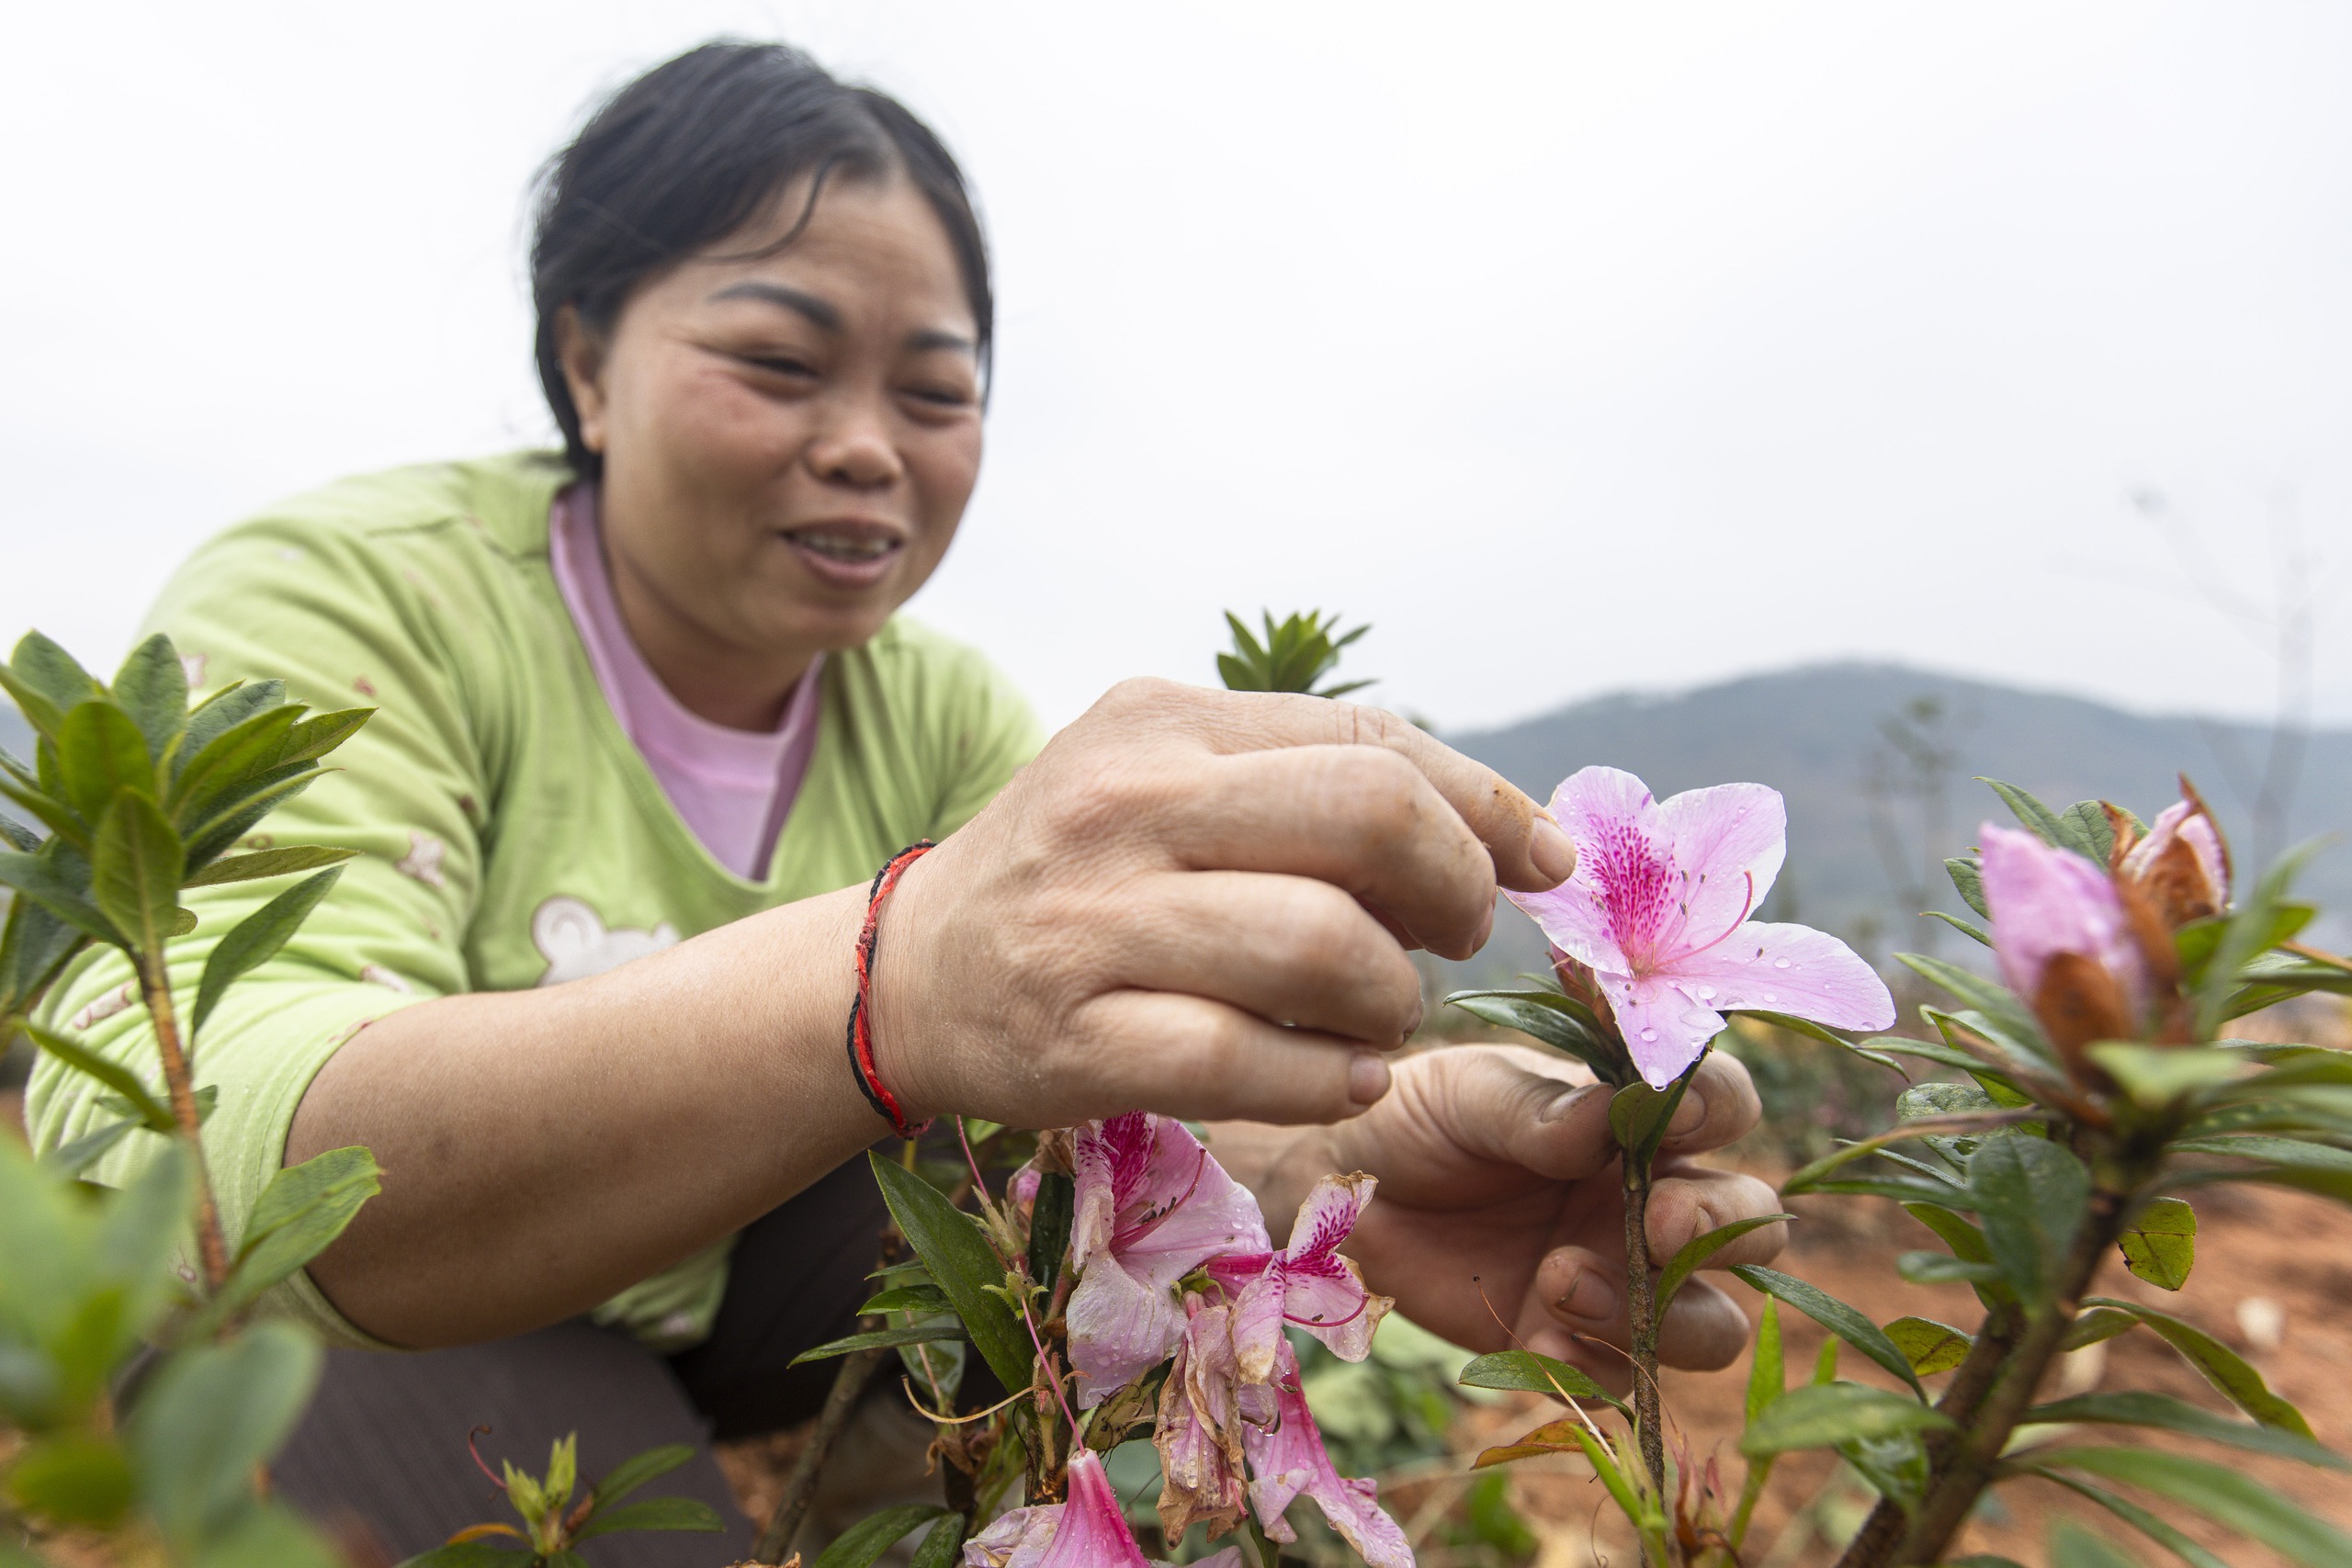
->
xmin=1077 ymin=989 xmax=1387 ymax=1126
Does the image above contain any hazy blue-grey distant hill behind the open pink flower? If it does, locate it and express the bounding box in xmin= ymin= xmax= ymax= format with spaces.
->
xmin=1446 ymin=663 xmax=2352 ymax=983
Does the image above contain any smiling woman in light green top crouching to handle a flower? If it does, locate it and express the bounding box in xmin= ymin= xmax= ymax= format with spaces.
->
xmin=30 ymin=45 xmax=1778 ymax=1561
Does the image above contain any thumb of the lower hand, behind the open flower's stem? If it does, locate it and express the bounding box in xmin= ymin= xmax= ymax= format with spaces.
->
xmin=1402 ymin=1046 xmax=1618 ymax=1182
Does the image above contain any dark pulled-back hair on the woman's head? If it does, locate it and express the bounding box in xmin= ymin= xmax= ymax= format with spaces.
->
xmin=532 ymin=42 xmax=995 ymax=478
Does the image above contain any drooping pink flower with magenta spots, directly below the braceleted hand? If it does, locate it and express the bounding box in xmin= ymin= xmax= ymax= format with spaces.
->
xmin=1066 ymin=1112 xmax=1268 ymax=1408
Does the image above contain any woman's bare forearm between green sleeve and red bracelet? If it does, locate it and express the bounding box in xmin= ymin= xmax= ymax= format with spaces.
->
xmin=287 ymin=888 xmax=887 ymax=1347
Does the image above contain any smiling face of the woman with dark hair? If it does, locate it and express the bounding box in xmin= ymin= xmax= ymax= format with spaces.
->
xmin=562 ymin=176 xmax=981 ymax=668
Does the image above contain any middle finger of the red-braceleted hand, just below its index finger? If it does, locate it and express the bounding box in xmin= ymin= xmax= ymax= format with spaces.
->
xmin=1171 ymin=745 xmax=1494 ymax=957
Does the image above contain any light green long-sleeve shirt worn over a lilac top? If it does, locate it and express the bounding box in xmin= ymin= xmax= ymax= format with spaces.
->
xmin=26 ymin=454 xmax=1040 ymax=1347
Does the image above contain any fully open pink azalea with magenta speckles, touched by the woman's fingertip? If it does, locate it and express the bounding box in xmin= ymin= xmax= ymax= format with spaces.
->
xmin=1510 ymin=769 xmax=1895 ymax=1089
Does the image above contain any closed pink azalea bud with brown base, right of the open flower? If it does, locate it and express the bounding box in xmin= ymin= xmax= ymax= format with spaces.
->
xmin=1978 ymin=811 xmax=2171 ymax=1034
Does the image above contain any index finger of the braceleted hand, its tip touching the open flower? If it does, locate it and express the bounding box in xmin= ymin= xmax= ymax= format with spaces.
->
xmin=1114 ymin=682 xmax=1576 ymax=894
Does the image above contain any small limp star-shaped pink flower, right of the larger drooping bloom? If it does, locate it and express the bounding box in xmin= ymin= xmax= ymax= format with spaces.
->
xmin=1209 ymin=1170 xmax=1397 ymax=1382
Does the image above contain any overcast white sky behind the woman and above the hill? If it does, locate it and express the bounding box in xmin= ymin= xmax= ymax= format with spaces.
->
xmin=0 ymin=0 xmax=2352 ymax=727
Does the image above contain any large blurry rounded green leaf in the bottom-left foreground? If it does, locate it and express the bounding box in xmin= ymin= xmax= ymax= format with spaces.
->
xmin=127 ymin=1324 xmax=320 ymax=1547
